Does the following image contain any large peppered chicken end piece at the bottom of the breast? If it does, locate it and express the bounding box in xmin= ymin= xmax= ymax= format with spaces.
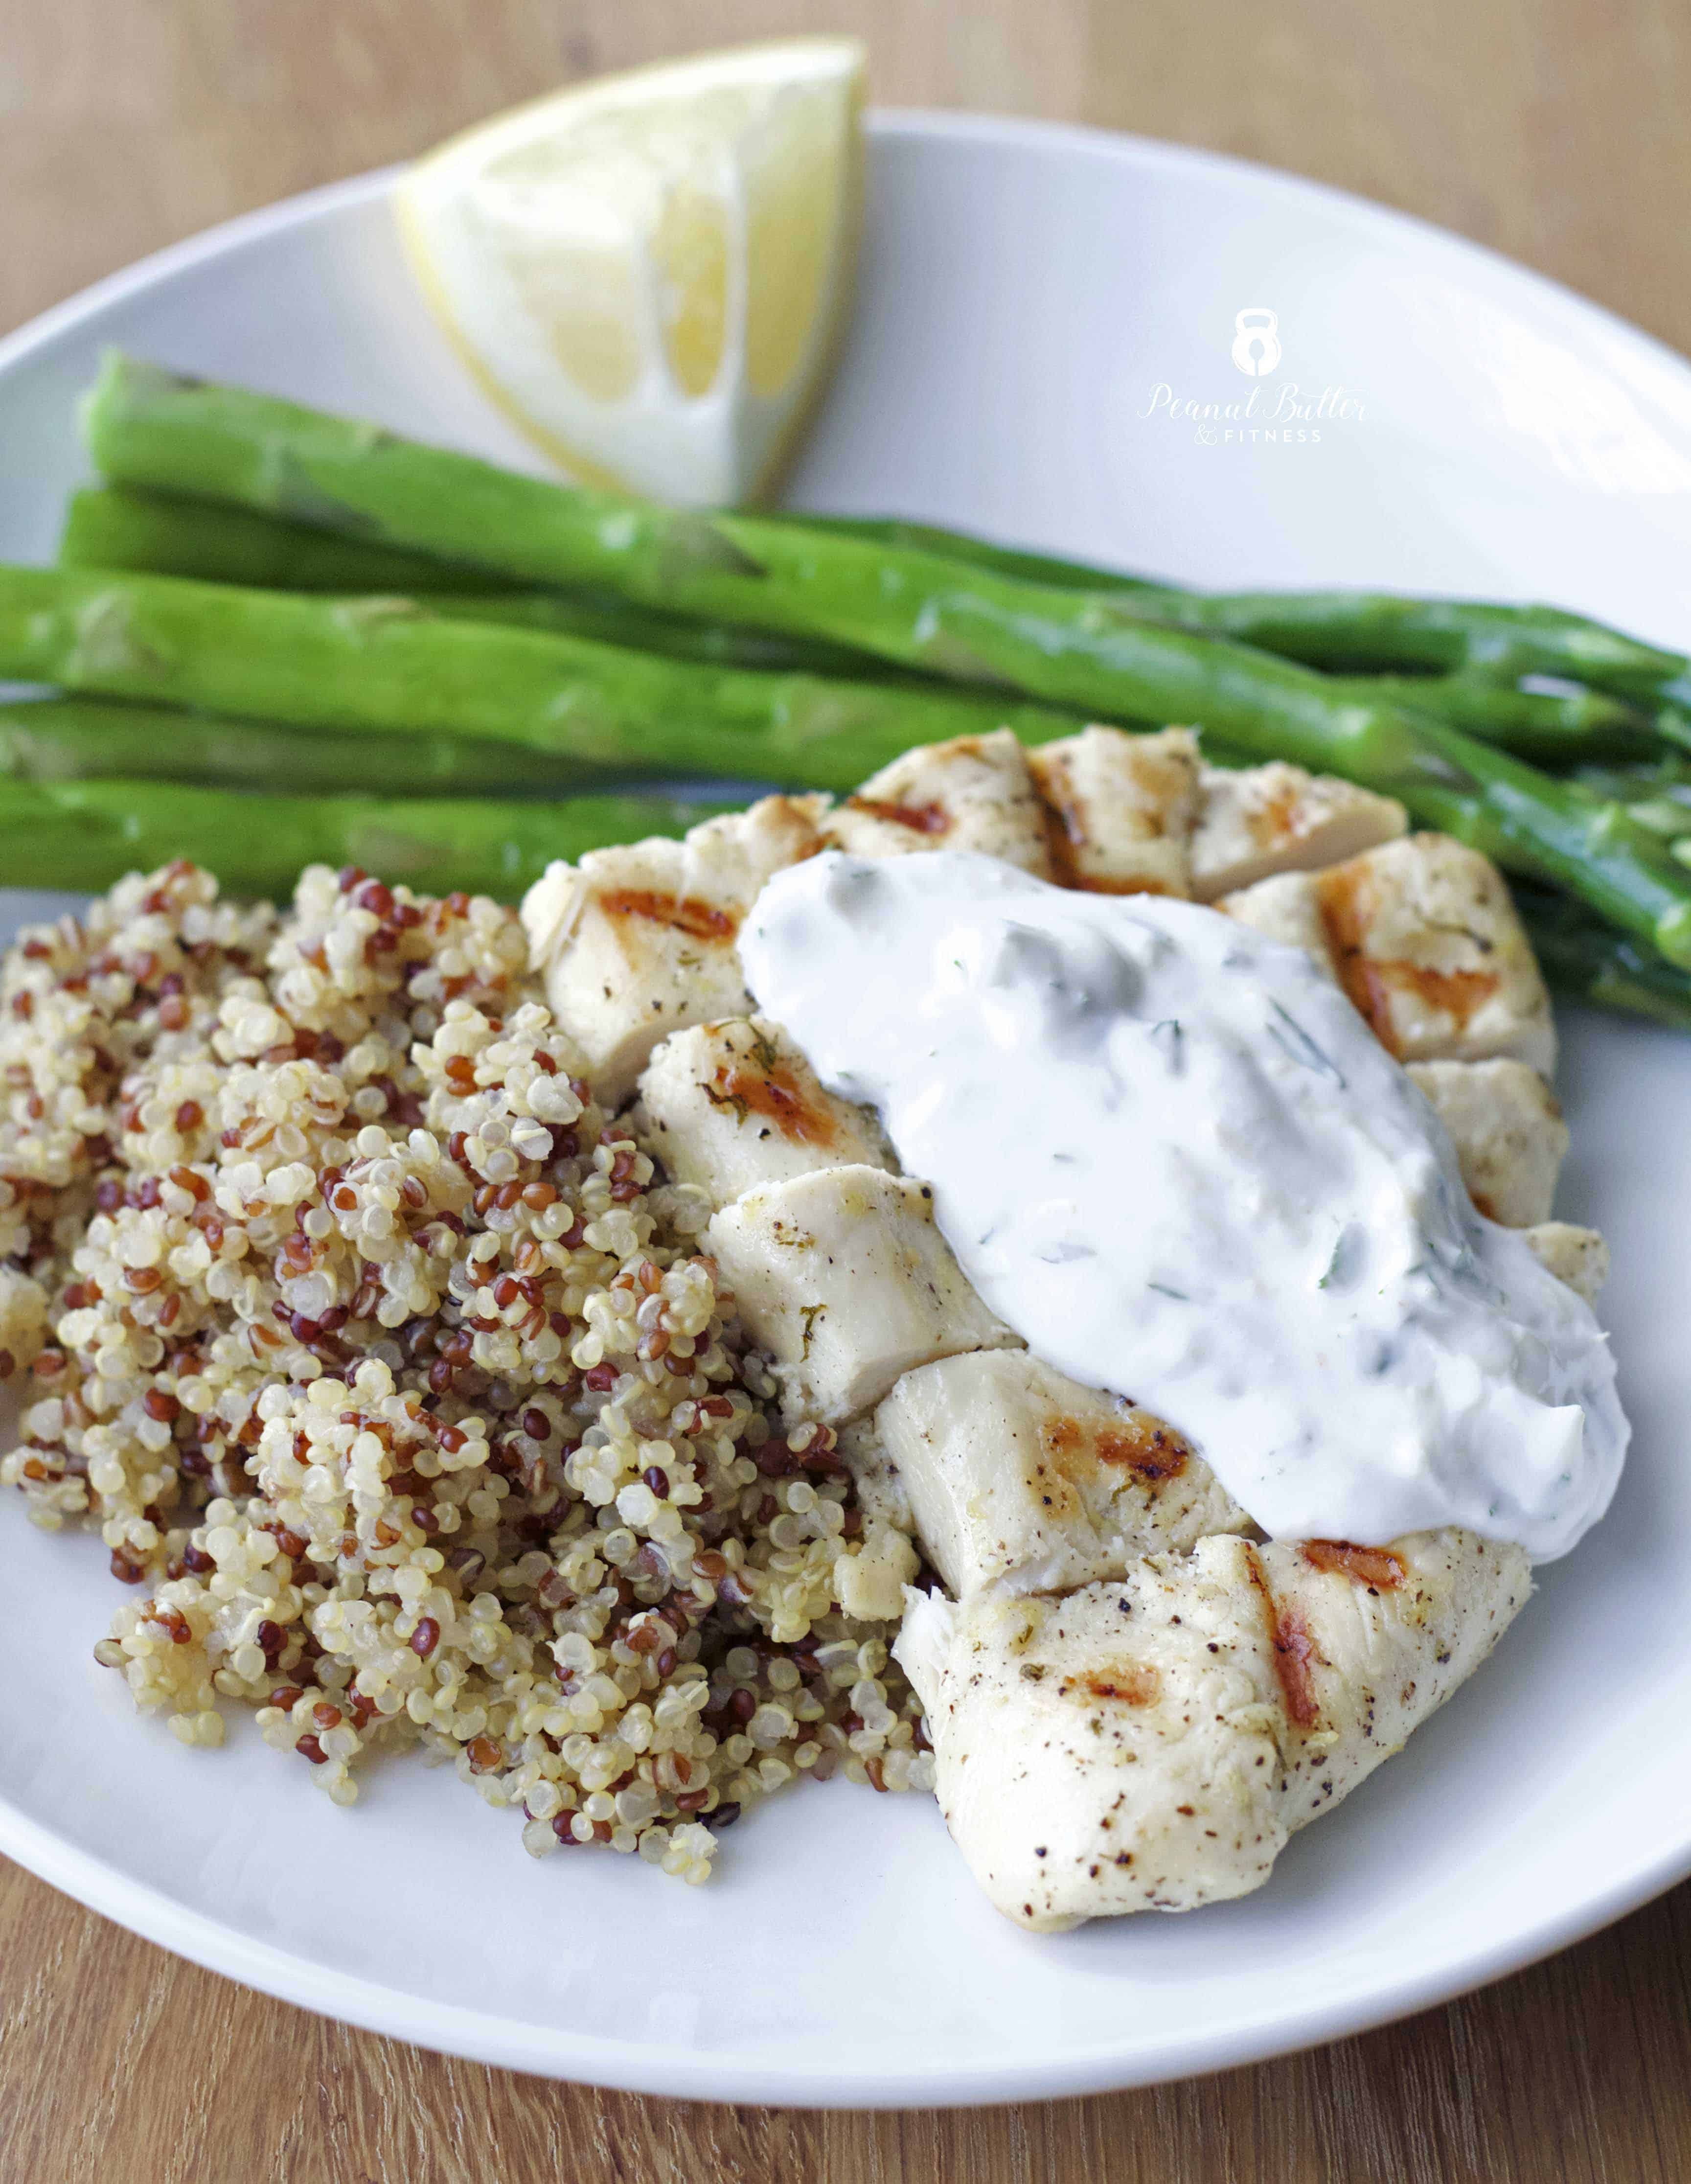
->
xmin=909 ymin=1531 xmax=1531 ymax=1931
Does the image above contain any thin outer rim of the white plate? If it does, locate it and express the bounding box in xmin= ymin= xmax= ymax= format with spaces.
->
xmin=0 ymin=107 xmax=1691 ymax=2108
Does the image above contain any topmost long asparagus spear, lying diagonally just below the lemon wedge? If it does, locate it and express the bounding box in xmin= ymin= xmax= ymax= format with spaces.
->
xmin=76 ymin=358 xmax=1691 ymax=963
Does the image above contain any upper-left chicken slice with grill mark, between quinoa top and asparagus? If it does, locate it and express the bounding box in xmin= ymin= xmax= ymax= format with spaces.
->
xmin=522 ymin=797 xmax=828 ymax=1107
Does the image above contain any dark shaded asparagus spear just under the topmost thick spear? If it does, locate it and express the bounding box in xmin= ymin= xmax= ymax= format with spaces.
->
xmin=59 ymin=485 xmax=885 ymax=675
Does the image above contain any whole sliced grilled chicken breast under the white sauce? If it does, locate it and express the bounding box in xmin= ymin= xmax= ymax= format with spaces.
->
xmin=525 ymin=747 xmax=1608 ymax=1931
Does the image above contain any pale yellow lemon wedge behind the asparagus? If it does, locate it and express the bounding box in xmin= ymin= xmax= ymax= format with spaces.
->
xmin=398 ymin=37 xmax=863 ymax=506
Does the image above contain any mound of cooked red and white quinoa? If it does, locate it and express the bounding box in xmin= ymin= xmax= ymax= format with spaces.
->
xmin=0 ymin=865 xmax=933 ymax=1881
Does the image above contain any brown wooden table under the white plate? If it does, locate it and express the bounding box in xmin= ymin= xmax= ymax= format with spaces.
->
xmin=0 ymin=0 xmax=1691 ymax=2184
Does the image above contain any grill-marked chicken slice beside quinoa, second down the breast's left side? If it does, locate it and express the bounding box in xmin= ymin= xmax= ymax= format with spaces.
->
xmin=634 ymin=1015 xmax=896 ymax=1206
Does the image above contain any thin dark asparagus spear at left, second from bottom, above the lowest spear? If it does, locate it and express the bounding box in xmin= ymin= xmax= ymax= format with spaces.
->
xmin=0 ymin=697 xmax=605 ymax=797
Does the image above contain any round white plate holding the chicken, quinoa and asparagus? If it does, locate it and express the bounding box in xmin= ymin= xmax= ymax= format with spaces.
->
xmin=0 ymin=116 xmax=1691 ymax=2105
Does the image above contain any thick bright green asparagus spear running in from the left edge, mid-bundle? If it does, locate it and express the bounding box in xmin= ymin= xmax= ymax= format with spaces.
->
xmin=0 ymin=566 xmax=1075 ymax=791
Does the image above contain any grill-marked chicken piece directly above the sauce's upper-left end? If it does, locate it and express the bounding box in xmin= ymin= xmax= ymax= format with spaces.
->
xmin=828 ymin=727 xmax=1051 ymax=880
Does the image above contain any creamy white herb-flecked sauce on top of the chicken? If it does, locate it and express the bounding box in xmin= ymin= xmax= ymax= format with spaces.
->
xmin=741 ymin=852 xmax=1628 ymax=1560
